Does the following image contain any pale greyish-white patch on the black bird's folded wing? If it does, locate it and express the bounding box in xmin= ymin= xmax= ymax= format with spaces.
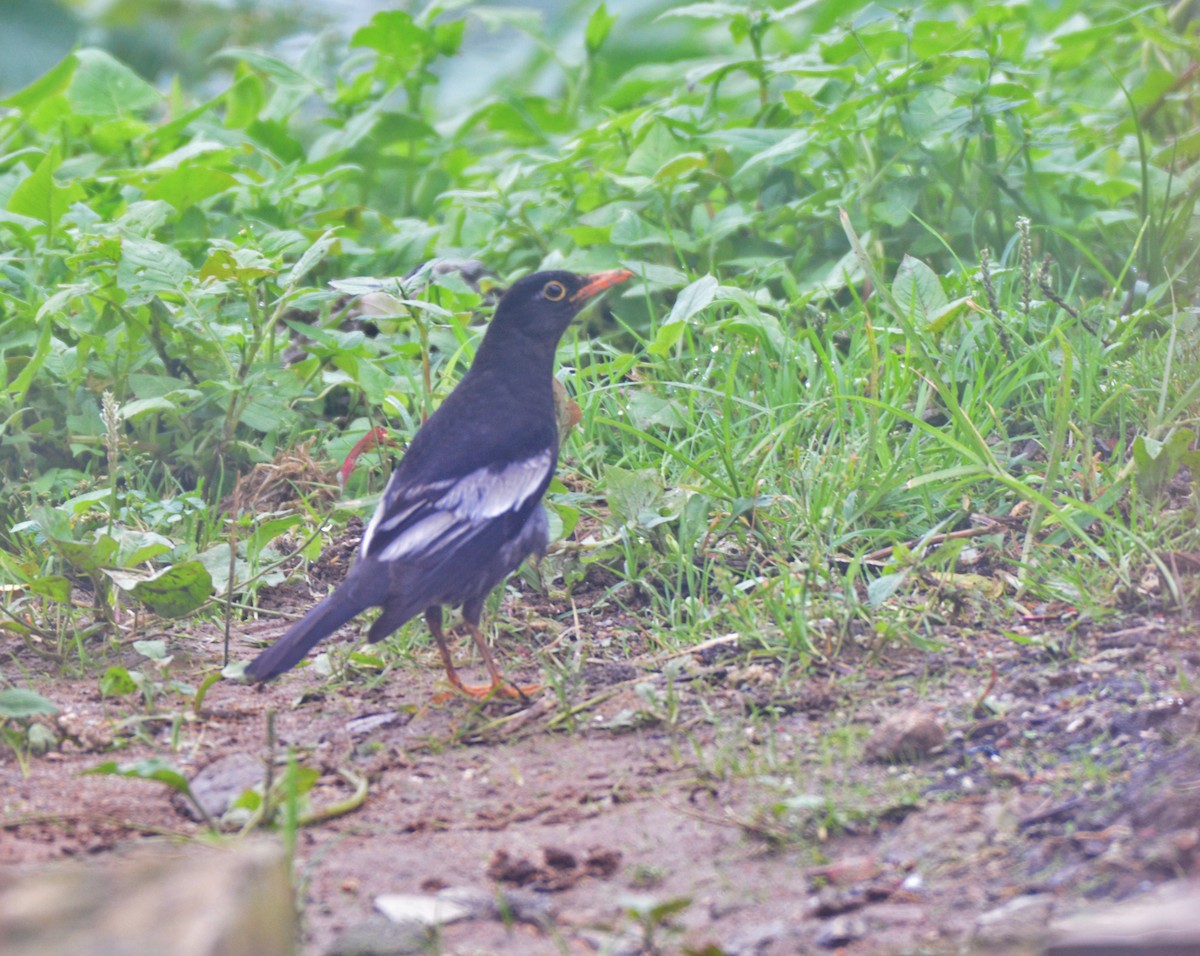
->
xmin=361 ymin=450 xmax=554 ymax=561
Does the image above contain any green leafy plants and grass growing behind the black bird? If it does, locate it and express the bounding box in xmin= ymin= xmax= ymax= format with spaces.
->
xmin=0 ymin=0 xmax=1200 ymax=686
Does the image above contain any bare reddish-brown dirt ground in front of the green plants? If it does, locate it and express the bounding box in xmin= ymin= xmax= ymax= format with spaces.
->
xmin=0 ymin=556 xmax=1200 ymax=956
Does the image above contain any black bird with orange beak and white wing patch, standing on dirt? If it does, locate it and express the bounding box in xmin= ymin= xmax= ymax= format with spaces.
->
xmin=246 ymin=269 xmax=632 ymax=698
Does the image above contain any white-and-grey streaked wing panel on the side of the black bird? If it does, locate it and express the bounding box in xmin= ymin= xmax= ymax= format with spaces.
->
xmin=360 ymin=449 xmax=556 ymax=561
